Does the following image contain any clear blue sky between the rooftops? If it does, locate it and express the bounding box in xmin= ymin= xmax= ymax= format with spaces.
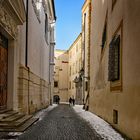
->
xmin=55 ymin=0 xmax=85 ymax=50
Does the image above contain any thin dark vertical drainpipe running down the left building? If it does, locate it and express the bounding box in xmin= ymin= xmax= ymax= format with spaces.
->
xmin=25 ymin=0 xmax=30 ymax=114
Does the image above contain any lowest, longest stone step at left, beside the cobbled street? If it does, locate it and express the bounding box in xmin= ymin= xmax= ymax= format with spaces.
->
xmin=0 ymin=118 xmax=38 ymax=132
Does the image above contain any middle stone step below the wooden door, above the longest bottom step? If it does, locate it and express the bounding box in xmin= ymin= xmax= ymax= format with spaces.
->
xmin=0 ymin=114 xmax=25 ymax=122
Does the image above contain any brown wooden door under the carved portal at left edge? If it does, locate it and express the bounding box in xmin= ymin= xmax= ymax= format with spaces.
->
xmin=0 ymin=33 xmax=8 ymax=109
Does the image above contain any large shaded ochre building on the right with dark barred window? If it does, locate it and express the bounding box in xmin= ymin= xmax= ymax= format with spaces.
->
xmin=89 ymin=0 xmax=140 ymax=140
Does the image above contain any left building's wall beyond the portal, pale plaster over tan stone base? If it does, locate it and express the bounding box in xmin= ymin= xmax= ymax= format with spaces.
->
xmin=17 ymin=0 xmax=55 ymax=113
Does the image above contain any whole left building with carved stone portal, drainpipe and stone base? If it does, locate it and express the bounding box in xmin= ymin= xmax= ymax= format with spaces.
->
xmin=0 ymin=0 xmax=56 ymax=114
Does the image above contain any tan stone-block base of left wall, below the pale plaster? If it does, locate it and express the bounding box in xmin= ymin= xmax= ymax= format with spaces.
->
xmin=17 ymin=66 xmax=49 ymax=113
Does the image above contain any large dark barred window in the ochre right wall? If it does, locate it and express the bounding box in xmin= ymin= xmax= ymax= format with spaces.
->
xmin=108 ymin=35 xmax=120 ymax=81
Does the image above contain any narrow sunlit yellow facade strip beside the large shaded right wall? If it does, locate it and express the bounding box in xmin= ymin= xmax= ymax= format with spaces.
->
xmin=81 ymin=0 xmax=91 ymax=109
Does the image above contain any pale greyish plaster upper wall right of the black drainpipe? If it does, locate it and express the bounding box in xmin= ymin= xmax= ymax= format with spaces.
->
xmin=28 ymin=1 xmax=49 ymax=81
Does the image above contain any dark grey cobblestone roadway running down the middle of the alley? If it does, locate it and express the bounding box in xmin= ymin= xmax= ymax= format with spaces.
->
xmin=18 ymin=104 xmax=101 ymax=140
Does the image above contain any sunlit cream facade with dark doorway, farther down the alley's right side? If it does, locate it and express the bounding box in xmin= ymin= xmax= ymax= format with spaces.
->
xmin=68 ymin=33 xmax=83 ymax=104
